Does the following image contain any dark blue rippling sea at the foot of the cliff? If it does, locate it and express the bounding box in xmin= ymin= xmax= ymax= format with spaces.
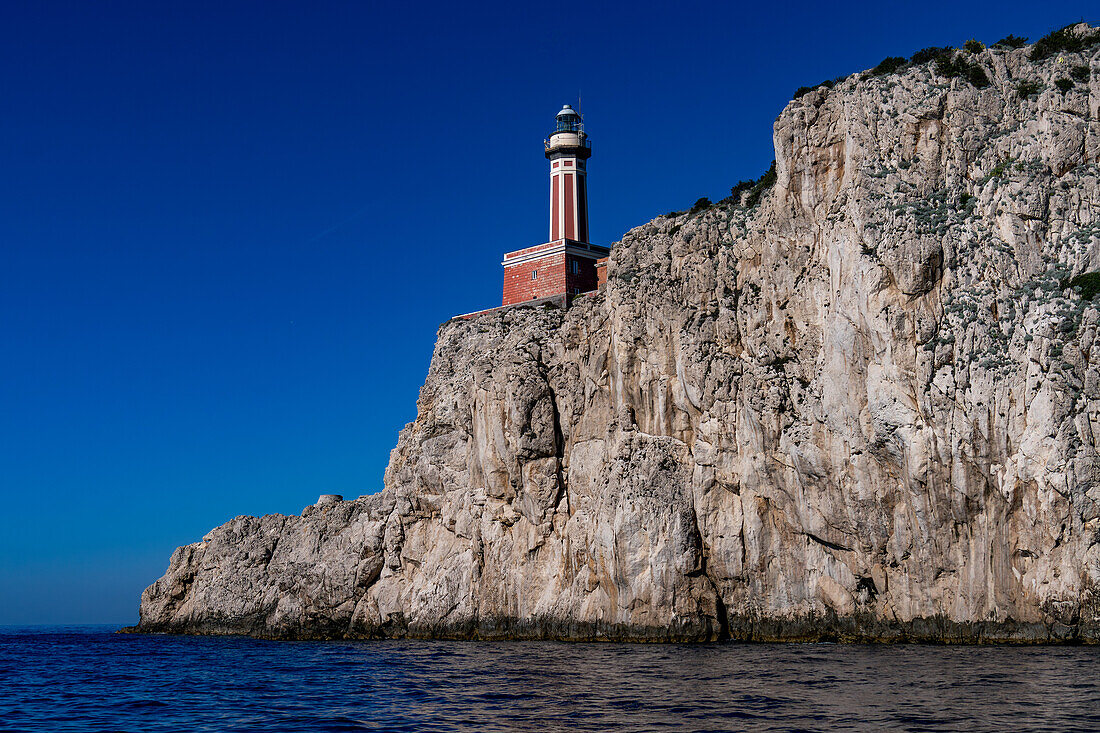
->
xmin=0 ymin=626 xmax=1100 ymax=733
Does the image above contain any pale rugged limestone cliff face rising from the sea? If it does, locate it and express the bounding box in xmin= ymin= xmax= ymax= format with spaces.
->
xmin=135 ymin=25 xmax=1100 ymax=642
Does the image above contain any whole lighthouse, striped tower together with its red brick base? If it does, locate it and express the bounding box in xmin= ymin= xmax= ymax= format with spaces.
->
xmin=502 ymin=105 xmax=609 ymax=305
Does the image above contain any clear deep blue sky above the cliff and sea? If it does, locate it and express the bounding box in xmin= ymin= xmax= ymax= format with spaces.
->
xmin=0 ymin=0 xmax=1100 ymax=623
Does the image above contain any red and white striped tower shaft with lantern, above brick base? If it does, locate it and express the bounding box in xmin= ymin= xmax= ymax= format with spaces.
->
xmin=545 ymin=105 xmax=592 ymax=242
